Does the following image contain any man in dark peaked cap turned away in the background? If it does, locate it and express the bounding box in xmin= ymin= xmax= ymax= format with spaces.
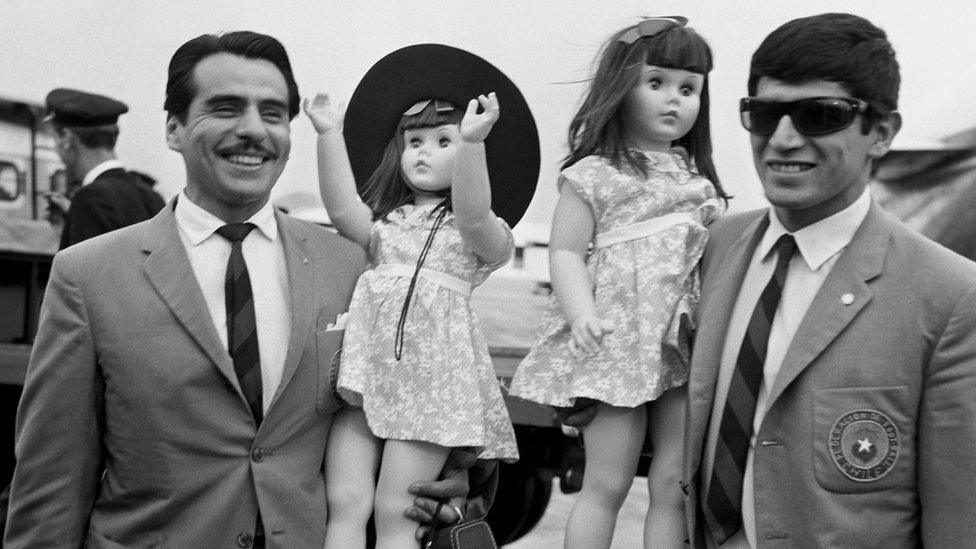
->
xmin=46 ymin=88 xmax=164 ymax=249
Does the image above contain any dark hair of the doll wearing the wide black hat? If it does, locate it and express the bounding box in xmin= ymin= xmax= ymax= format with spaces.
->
xmin=362 ymin=100 xmax=464 ymax=220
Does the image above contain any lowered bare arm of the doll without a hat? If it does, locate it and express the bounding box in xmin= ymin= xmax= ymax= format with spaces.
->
xmin=549 ymin=184 xmax=613 ymax=355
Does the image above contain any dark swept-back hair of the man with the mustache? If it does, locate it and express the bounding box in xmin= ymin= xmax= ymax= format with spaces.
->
xmin=163 ymin=31 xmax=299 ymax=123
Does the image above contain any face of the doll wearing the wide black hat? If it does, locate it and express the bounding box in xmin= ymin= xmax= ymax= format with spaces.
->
xmin=400 ymin=124 xmax=461 ymax=192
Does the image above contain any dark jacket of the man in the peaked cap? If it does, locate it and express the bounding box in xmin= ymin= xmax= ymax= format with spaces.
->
xmin=61 ymin=168 xmax=165 ymax=250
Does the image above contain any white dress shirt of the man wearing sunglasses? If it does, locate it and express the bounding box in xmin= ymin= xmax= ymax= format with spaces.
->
xmin=702 ymin=189 xmax=871 ymax=549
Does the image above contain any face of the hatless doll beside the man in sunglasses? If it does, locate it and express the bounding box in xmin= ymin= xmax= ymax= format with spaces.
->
xmin=622 ymin=65 xmax=705 ymax=151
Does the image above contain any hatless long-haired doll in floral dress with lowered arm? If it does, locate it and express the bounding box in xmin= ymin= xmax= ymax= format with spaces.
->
xmin=511 ymin=17 xmax=724 ymax=549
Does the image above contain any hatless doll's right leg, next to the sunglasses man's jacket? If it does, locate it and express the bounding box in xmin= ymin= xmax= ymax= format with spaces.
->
xmin=644 ymin=387 xmax=688 ymax=549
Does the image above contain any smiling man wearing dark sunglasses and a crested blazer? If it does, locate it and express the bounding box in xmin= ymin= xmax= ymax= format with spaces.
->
xmin=685 ymin=10 xmax=976 ymax=548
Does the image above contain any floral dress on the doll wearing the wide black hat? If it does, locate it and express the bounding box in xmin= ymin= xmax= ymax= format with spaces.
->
xmin=337 ymin=205 xmax=518 ymax=460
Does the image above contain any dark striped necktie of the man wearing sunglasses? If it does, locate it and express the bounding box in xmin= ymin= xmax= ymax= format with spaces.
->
xmin=704 ymin=234 xmax=796 ymax=544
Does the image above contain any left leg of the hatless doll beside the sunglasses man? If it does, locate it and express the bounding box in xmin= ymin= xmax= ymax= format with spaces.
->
xmin=565 ymin=404 xmax=647 ymax=549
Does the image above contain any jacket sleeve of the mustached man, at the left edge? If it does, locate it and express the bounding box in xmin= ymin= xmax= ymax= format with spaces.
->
xmin=5 ymin=253 xmax=104 ymax=548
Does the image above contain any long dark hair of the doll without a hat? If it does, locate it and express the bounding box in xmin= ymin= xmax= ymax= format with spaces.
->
xmin=562 ymin=20 xmax=729 ymax=199
